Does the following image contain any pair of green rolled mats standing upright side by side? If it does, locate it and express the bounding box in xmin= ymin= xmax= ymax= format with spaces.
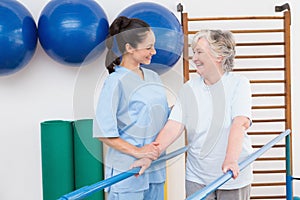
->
xmin=40 ymin=119 xmax=104 ymax=200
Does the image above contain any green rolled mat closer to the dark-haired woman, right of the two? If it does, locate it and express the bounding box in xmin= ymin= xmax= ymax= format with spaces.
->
xmin=73 ymin=119 xmax=104 ymax=200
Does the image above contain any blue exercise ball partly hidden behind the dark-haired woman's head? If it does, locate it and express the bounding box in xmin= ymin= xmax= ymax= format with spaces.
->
xmin=118 ymin=2 xmax=183 ymax=74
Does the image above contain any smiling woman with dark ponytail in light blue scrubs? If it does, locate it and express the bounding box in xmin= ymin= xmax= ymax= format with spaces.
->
xmin=94 ymin=16 xmax=169 ymax=200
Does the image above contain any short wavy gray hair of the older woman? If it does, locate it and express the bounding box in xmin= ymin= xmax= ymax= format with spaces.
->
xmin=192 ymin=30 xmax=236 ymax=72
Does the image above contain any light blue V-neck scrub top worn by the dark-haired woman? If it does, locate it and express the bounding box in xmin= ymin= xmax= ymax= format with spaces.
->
xmin=93 ymin=66 xmax=169 ymax=192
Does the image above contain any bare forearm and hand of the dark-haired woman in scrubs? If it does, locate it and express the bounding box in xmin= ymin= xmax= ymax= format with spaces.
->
xmin=99 ymin=137 xmax=160 ymax=160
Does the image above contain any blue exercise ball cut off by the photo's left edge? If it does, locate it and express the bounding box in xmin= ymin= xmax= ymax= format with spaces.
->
xmin=0 ymin=0 xmax=37 ymax=75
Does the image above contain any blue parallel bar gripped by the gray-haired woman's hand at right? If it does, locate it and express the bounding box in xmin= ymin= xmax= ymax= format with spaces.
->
xmin=186 ymin=129 xmax=291 ymax=200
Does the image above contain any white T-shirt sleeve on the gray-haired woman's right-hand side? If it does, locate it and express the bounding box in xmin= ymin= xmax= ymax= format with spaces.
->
xmin=232 ymin=77 xmax=252 ymax=121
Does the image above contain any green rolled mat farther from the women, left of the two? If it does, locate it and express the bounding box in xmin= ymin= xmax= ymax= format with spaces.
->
xmin=41 ymin=120 xmax=75 ymax=200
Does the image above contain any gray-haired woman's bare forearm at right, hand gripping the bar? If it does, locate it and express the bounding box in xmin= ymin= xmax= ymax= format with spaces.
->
xmin=222 ymin=116 xmax=250 ymax=179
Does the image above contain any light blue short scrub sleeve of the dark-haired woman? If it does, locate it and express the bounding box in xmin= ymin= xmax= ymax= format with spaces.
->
xmin=93 ymin=77 xmax=122 ymax=137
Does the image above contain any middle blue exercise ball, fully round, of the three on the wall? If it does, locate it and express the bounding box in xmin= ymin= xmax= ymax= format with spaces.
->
xmin=38 ymin=0 xmax=108 ymax=66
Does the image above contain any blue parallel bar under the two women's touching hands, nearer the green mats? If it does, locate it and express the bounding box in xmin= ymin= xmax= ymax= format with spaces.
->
xmin=58 ymin=146 xmax=188 ymax=200
